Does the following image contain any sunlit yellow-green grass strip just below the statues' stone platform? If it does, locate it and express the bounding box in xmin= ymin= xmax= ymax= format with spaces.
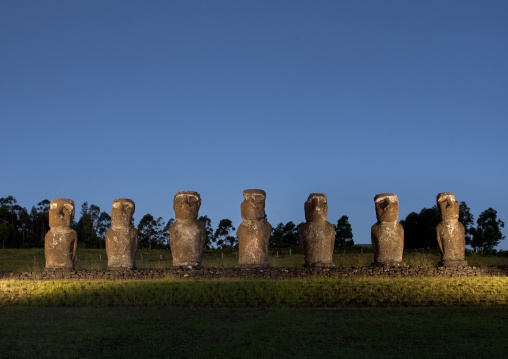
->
xmin=0 ymin=277 xmax=508 ymax=308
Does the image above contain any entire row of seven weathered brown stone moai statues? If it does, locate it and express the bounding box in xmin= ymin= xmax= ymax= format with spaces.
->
xmin=45 ymin=189 xmax=467 ymax=270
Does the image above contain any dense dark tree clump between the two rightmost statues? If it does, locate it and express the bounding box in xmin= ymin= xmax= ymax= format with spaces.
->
xmin=400 ymin=205 xmax=441 ymax=248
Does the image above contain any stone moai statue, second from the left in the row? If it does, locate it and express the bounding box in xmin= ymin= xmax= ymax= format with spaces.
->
xmin=106 ymin=198 xmax=138 ymax=269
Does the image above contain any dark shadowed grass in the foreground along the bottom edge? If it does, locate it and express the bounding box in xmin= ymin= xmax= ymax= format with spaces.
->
xmin=0 ymin=307 xmax=508 ymax=359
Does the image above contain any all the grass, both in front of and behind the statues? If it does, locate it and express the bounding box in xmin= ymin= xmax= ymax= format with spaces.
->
xmin=0 ymin=249 xmax=508 ymax=359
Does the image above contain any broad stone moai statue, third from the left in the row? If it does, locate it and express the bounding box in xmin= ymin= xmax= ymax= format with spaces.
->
xmin=169 ymin=191 xmax=206 ymax=268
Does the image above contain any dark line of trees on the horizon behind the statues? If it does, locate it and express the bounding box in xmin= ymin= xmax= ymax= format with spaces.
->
xmin=0 ymin=196 xmax=505 ymax=253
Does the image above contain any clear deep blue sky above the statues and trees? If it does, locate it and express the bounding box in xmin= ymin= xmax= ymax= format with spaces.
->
xmin=0 ymin=0 xmax=508 ymax=249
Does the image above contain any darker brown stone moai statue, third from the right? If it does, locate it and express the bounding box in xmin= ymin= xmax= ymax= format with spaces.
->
xmin=298 ymin=193 xmax=335 ymax=267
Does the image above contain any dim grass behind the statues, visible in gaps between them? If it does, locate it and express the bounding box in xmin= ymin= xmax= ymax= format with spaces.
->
xmin=0 ymin=246 xmax=508 ymax=272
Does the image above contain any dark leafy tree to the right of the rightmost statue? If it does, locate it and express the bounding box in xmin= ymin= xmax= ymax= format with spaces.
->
xmin=471 ymin=208 xmax=505 ymax=253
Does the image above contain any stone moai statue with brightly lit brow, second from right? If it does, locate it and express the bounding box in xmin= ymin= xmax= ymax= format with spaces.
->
xmin=371 ymin=193 xmax=405 ymax=266
